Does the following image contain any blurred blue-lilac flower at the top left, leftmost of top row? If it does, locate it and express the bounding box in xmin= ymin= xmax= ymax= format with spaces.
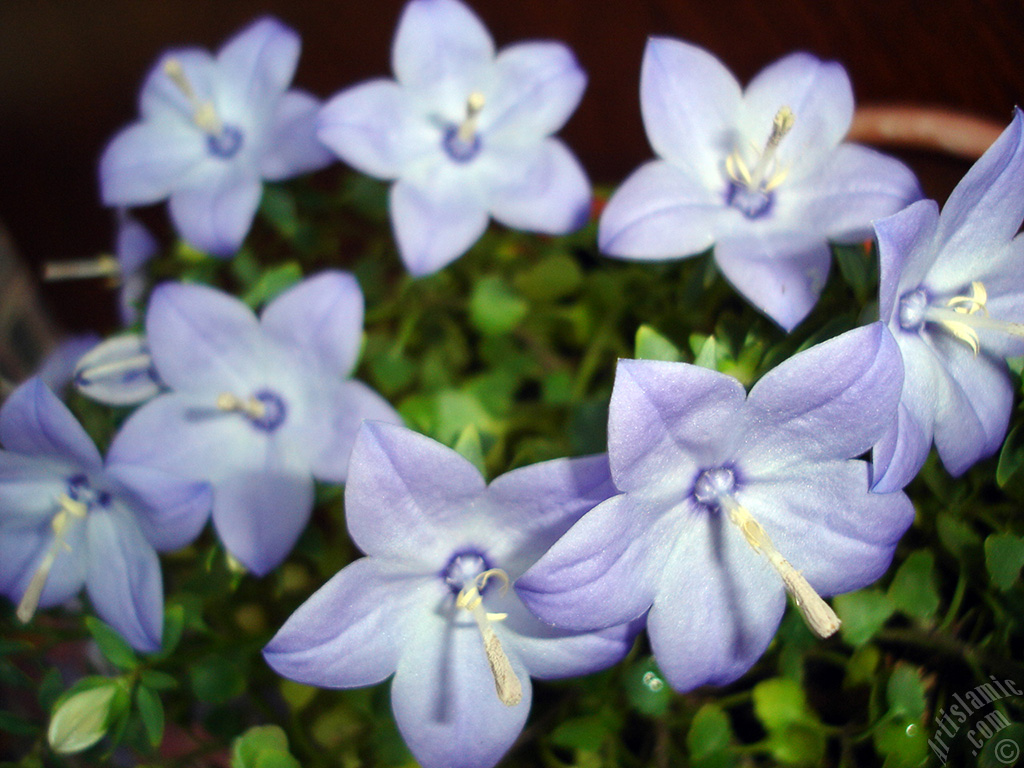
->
xmin=99 ymin=17 xmax=331 ymax=256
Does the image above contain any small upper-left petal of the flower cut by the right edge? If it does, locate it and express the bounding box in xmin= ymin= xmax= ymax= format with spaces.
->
xmin=874 ymin=200 xmax=939 ymax=323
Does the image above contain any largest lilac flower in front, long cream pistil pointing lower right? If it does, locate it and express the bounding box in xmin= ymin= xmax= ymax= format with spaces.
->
xmin=516 ymin=323 xmax=913 ymax=690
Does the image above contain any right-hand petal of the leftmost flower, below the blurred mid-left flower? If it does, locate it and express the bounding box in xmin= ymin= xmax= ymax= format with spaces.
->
xmin=106 ymin=460 xmax=213 ymax=552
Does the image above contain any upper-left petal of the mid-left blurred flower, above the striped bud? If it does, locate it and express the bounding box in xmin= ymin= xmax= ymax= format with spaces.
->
xmin=145 ymin=283 xmax=263 ymax=393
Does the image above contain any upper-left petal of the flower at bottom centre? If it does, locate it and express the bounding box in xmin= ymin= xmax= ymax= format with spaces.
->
xmin=345 ymin=422 xmax=485 ymax=567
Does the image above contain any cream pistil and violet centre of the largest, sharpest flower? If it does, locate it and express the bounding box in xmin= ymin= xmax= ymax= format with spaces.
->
xmin=693 ymin=467 xmax=840 ymax=638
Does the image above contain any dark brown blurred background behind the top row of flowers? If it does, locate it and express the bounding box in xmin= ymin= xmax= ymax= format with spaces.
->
xmin=0 ymin=0 xmax=1024 ymax=335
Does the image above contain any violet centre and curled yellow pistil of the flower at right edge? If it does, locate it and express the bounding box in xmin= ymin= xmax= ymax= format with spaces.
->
xmin=899 ymin=281 xmax=1024 ymax=355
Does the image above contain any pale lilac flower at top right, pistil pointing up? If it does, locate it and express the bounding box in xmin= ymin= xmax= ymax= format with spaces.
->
xmin=598 ymin=38 xmax=921 ymax=331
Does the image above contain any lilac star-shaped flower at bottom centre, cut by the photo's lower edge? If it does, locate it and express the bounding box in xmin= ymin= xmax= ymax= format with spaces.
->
xmin=263 ymin=423 xmax=638 ymax=768
